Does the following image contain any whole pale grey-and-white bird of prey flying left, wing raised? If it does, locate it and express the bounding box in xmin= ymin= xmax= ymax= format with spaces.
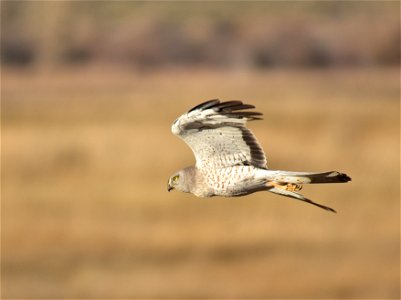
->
xmin=167 ymin=99 xmax=351 ymax=212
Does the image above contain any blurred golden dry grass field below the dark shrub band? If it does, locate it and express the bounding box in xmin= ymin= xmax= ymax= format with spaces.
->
xmin=1 ymin=68 xmax=400 ymax=299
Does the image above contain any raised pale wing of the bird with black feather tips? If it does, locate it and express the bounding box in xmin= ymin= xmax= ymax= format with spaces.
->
xmin=171 ymin=99 xmax=267 ymax=168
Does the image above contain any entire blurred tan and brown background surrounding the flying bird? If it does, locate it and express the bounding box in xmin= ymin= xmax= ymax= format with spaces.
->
xmin=1 ymin=1 xmax=400 ymax=299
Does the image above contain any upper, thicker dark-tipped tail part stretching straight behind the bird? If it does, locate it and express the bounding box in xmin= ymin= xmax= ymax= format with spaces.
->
xmin=271 ymin=171 xmax=351 ymax=184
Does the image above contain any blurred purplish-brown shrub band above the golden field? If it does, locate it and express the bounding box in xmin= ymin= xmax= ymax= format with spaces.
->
xmin=1 ymin=1 xmax=400 ymax=69
